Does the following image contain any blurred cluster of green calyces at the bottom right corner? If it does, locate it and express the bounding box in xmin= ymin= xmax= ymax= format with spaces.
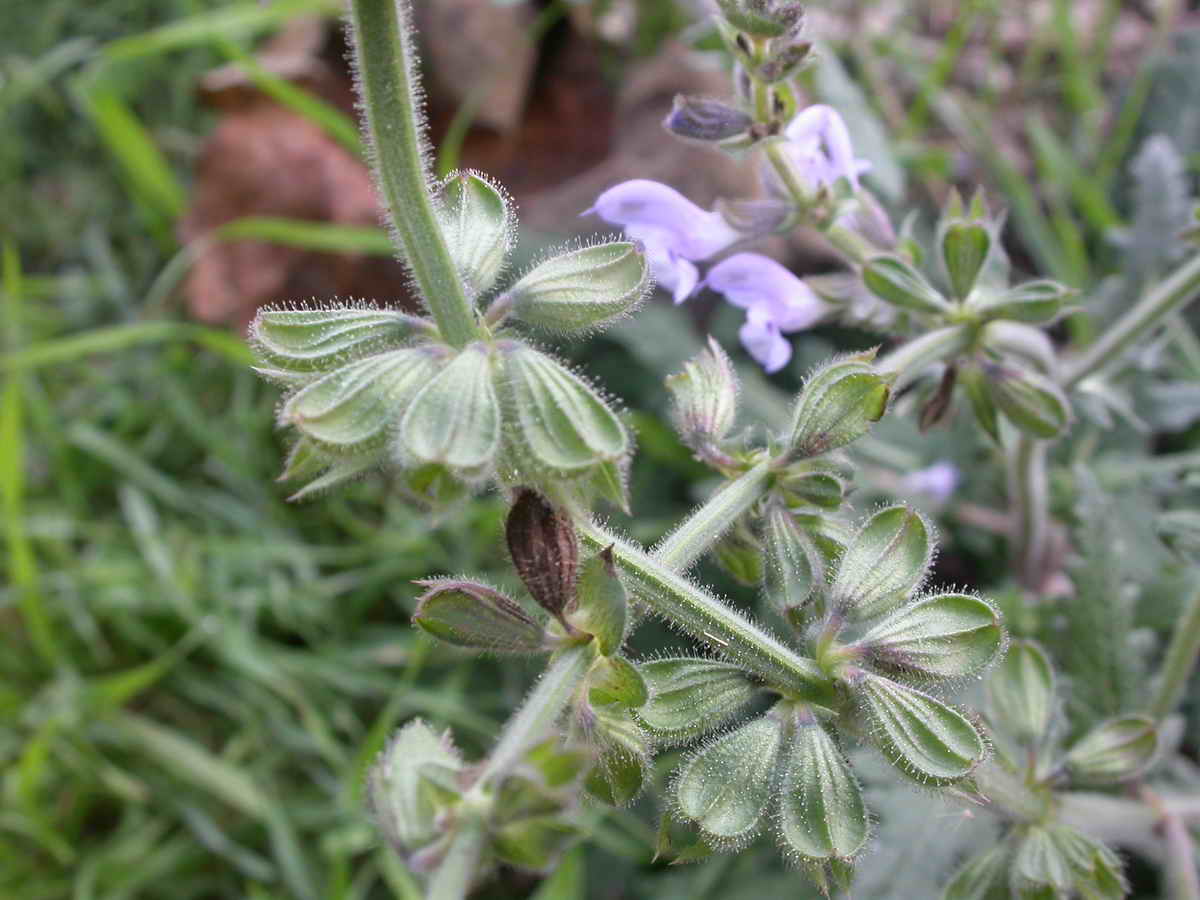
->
xmin=942 ymin=641 xmax=1158 ymax=900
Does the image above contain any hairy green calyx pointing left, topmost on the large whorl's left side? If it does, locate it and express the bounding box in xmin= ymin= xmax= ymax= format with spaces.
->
xmin=250 ymin=306 xmax=428 ymax=373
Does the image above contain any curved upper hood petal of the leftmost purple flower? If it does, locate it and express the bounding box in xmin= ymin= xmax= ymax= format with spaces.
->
xmin=588 ymin=179 xmax=740 ymax=259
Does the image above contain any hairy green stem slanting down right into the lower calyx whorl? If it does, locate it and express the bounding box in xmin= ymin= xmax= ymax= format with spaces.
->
xmin=576 ymin=521 xmax=832 ymax=702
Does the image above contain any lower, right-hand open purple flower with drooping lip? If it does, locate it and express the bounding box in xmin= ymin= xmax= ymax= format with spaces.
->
xmin=704 ymin=253 xmax=833 ymax=372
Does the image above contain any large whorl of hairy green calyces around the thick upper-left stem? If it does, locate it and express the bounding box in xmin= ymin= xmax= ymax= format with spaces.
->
xmin=251 ymin=173 xmax=650 ymax=505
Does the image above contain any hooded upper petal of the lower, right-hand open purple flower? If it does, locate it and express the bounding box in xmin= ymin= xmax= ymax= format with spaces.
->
xmin=704 ymin=253 xmax=830 ymax=332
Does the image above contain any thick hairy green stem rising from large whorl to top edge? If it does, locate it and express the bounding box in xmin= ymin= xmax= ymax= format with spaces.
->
xmin=350 ymin=0 xmax=479 ymax=347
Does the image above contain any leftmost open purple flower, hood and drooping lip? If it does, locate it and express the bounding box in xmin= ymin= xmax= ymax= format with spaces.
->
xmin=583 ymin=179 xmax=742 ymax=304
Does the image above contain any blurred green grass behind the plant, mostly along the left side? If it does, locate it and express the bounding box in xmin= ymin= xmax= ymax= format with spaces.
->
xmin=0 ymin=0 xmax=1200 ymax=900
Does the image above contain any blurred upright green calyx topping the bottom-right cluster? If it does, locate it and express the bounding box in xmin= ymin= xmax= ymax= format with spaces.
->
xmin=988 ymin=641 xmax=1055 ymax=746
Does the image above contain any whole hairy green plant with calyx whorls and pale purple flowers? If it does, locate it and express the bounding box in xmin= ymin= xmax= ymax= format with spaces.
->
xmin=243 ymin=0 xmax=1200 ymax=900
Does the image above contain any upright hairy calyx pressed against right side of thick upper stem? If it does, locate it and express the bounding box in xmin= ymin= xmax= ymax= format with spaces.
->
xmin=433 ymin=172 xmax=517 ymax=296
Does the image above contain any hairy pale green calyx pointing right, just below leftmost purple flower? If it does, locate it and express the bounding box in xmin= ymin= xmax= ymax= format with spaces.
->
xmin=506 ymin=241 xmax=654 ymax=335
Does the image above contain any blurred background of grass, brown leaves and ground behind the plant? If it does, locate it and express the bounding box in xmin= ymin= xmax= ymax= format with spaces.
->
xmin=7 ymin=0 xmax=1200 ymax=900
